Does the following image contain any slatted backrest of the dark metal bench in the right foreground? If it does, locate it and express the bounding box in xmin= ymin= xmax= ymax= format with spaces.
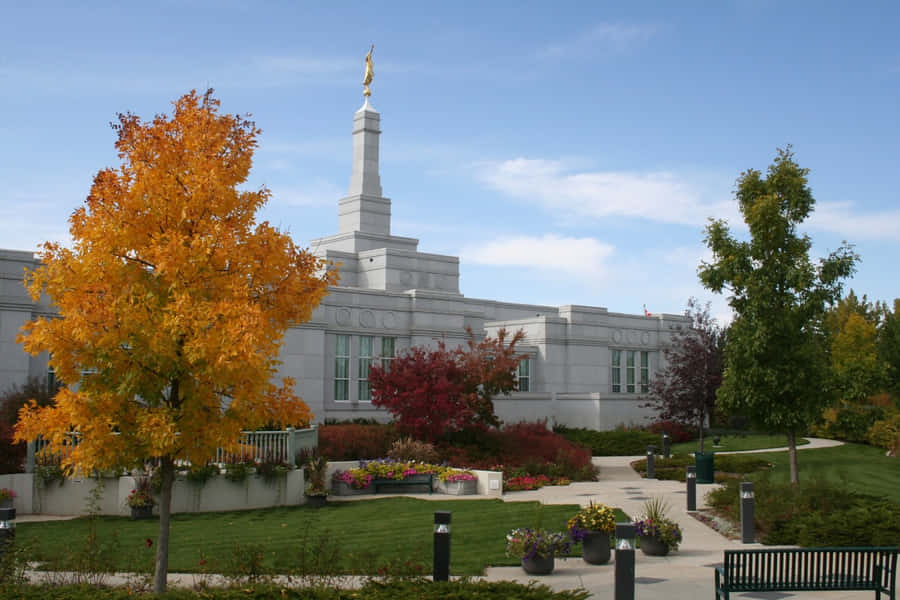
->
xmin=723 ymin=547 xmax=898 ymax=589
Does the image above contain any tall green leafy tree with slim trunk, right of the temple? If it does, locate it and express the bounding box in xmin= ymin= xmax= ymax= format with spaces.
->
xmin=699 ymin=147 xmax=859 ymax=483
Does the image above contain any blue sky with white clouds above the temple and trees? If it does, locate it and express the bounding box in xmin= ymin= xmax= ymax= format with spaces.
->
xmin=0 ymin=0 xmax=900 ymax=324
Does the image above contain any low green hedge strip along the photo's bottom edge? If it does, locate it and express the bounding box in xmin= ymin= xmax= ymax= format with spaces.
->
xmin=0 ymin=579 xmax=590 ymax=600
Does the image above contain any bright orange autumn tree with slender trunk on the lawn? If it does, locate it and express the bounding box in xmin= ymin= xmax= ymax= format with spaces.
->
xmin=16 ymin=90 xmax=335 ymax=592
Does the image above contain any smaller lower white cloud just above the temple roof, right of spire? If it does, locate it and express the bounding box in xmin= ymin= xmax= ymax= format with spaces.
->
xmin=460 ymin=234 xmax=615 ymax=277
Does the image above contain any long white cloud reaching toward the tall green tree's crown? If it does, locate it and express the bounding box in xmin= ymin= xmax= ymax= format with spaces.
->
xmin=477 ymin=158 xmax=736 ymax=225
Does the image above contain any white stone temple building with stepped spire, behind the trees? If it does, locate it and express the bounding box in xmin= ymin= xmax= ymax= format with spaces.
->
xmin=0 ymin=91 xmax=690 ymax=429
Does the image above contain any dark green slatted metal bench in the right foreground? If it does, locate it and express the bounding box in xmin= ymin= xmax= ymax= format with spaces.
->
xmin=715 ymin=547 xmax=898 ymax=600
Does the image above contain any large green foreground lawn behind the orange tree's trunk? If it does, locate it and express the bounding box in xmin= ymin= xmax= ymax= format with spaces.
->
xmin=16 ymin=498 xmax=628 ymax=575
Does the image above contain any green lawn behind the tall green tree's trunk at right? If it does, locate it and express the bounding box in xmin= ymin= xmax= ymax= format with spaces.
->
xmin=744 ymin=444 xmax=900 ymax=504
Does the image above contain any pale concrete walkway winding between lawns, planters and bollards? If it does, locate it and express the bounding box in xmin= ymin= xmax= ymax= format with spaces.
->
xmin=24 ymin=438 xmax=872 ymax=600
